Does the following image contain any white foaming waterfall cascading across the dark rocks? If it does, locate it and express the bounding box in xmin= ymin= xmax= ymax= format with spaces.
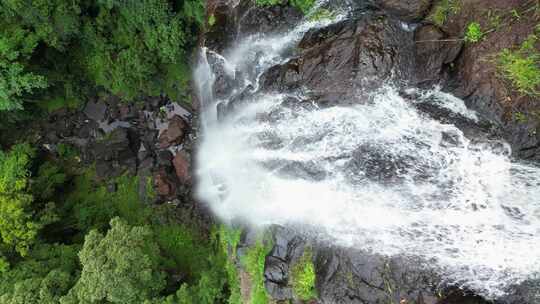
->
xmin=197 ymin=3 xmax=540 ymax=297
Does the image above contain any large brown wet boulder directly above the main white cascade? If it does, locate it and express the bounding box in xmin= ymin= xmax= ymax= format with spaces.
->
xmin=261 ymin=14 xmax=415 ymax=104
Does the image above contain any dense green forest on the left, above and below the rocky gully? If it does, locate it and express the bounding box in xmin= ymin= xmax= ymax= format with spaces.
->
xmin=0 ymin=0 xmax=239 ymax=304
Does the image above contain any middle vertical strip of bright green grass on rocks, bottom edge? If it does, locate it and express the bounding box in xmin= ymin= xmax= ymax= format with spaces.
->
xmin=242 ymin=235 xmax=272 ymax=304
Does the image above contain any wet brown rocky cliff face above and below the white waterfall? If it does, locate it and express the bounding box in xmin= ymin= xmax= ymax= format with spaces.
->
xmin=202 ymin=0 xmax=540 ymax=304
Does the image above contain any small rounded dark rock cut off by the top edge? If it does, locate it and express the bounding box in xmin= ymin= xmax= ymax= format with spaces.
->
xmin=375 ymin=0 xmax=433 ymax=21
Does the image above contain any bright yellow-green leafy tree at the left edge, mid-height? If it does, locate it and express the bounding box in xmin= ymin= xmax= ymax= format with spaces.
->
xmin=0 ymin=144 xmax=55 ymax=256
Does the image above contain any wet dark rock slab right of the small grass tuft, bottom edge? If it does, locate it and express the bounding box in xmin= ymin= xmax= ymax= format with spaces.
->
xmin=316 ymin=248 xmax=440 ymax=304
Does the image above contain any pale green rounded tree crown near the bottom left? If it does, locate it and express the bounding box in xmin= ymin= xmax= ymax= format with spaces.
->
xmin=61 ymin=218 xmax=165 ymax=304
